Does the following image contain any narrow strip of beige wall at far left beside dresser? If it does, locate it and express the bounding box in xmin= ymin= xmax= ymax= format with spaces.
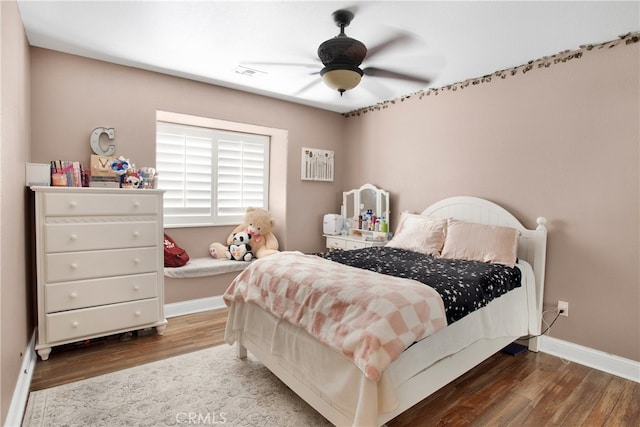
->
xmin=0 ymin=1 xmax=33 ymax=424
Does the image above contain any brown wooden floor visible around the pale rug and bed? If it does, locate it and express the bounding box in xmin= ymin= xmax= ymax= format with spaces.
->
xmin=31 ymin=310 xmax=640 ymax=427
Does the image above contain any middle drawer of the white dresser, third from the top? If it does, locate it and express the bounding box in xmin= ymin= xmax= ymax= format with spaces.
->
xmin=44 ymin=247 xmax=160 ymax=283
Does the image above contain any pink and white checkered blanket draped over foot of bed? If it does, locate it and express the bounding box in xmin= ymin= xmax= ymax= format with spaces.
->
xmin=224 ymin=252 xmax=447 ymax=381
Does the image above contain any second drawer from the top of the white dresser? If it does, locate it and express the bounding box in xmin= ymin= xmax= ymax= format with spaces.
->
xmin=44 ymin=221 xmax=159 ymax=253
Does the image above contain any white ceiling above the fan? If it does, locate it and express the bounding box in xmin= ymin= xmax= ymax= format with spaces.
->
xmin=18 ymin=0 xmax=640 ymax=112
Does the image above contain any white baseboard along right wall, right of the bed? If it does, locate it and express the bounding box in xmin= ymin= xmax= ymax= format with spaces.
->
xmin=540 ymin=335 xmax=640 ymax=383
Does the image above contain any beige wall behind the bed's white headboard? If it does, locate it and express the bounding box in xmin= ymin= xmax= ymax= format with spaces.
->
xmin=344 ymin=43 xmax=640 ymax=361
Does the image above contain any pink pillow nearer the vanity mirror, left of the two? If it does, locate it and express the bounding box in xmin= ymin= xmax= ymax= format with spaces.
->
xmin=387 ymin=212 xmax=447 ymax=255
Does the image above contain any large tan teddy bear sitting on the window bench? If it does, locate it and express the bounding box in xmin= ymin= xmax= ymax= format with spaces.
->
xmin=209 ymin=207 xmax=279 ymax=259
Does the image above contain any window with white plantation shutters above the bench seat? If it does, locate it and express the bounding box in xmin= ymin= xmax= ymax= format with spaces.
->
xmin=156 ymin=117 xmax=270 ymax=227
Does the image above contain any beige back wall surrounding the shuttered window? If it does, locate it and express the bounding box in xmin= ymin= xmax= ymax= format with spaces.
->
xmin=31 ymin=48 xmax=346 ymax=303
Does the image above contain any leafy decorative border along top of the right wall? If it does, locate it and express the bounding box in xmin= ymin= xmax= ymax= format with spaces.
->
xmin=342 ymin=32 xmax=640 ymax=117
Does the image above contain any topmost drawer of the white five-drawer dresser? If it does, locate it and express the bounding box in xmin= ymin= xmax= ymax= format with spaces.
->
xmin=44 ymin=194 xmax=160 ymax=216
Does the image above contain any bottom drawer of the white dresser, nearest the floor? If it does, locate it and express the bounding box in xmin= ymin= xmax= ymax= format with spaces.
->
xmin=46 ymin=298 xmax=160 ymax=343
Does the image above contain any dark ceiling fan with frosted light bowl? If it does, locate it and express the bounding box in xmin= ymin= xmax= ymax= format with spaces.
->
xmin=318 ymin=9 xmax=431 ymax=96
